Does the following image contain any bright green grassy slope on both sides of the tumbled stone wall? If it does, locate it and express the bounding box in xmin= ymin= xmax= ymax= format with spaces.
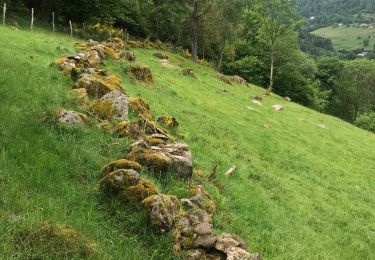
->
xmin=0 ymin=27 xmax=375 ymax=259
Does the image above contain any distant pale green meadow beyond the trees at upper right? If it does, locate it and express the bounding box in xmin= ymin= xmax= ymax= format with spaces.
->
xmin=312 ymin=26 xmax=375 ymax=50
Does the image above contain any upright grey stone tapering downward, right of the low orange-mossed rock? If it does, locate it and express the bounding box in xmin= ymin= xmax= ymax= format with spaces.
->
xmin=142 ymin=194 xmax=181 ymax=233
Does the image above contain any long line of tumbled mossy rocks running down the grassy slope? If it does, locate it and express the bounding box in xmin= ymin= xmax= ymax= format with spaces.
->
xmin=56 ymin=39 xmax=261 ymax=260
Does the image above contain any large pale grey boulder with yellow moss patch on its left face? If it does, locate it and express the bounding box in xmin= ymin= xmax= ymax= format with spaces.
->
xmin=91 ymin=90 xmax=129 ymax=121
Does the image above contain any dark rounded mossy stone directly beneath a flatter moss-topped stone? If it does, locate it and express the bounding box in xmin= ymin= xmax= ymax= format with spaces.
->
xmin=100 ymin=169 xmax=139 ymax=192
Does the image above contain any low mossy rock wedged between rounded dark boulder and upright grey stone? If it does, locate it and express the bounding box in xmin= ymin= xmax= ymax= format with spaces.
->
xmin=120 ymin=179 xmax=159 ymax=202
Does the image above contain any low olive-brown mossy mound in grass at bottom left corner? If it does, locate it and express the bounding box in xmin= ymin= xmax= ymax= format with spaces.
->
xmin=15 ymin=222 xmax=99 ymax=259
